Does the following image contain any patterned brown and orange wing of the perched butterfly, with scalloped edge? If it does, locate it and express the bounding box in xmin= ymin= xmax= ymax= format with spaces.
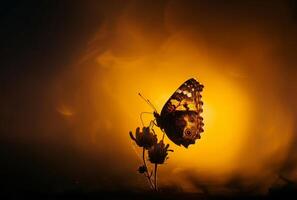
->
xmin=160 ymin=78 xmax=204 ymax=147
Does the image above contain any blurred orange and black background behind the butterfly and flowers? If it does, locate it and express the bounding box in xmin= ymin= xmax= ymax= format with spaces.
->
xmin=0 ymin=0 xmax=297 ymax=197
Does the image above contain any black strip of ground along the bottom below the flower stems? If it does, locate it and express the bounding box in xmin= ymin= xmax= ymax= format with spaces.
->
xmin=0 ymin=185 xmax=297 ymax=200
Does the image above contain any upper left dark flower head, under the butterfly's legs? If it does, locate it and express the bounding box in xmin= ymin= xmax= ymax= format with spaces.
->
xmin=129 ymin=127 xmax=158 ymax=149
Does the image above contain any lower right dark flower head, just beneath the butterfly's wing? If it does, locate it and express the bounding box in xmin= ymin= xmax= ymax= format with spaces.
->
xmin=148 ymin=140 xmax=173 ymax=164
